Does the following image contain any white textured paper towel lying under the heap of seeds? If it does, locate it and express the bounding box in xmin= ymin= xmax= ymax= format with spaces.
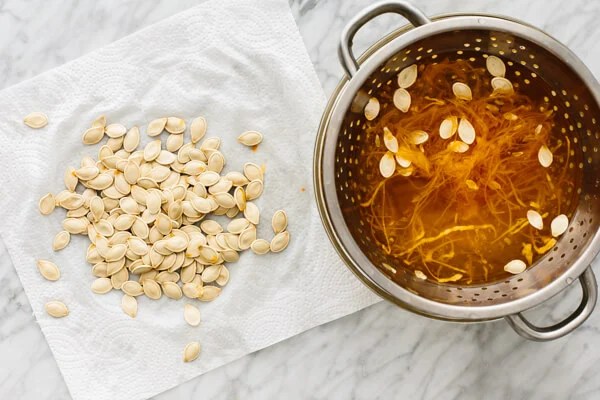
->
xmin=0 ymin=0 xmax=376 ymax=400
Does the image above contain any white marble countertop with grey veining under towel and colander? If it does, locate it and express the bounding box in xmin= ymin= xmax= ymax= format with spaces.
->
xmin=0 ymin=0 xmax=600 ymax=400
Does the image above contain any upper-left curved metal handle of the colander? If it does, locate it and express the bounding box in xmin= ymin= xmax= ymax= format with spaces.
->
xmin=339 ymin=0 xmax=431 ymax=78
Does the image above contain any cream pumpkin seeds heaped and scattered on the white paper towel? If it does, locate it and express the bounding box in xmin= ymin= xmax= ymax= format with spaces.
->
xmin=32 ymin=113 xmax=290 ymax=362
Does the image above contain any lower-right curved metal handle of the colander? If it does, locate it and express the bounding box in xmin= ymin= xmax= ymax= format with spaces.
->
xmin=505 ymin=267 xmax=598 ymax=342
